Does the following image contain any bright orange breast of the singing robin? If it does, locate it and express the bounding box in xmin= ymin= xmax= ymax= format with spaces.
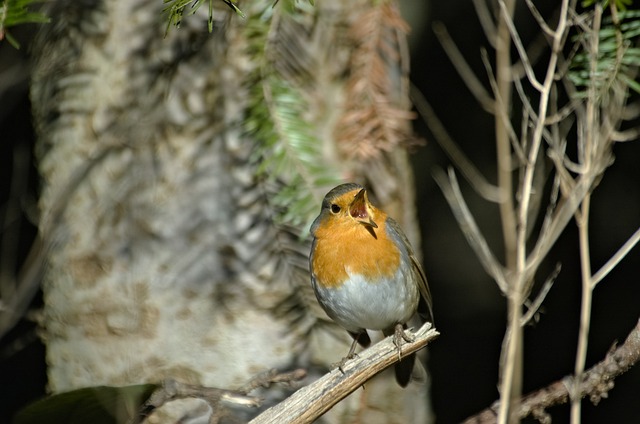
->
xmin=311 ymin=217 xmax=400 ymax=287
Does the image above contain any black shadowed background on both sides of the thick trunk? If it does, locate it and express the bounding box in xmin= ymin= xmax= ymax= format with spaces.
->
xmin=0 ymin=0 xmax=640 ymax=423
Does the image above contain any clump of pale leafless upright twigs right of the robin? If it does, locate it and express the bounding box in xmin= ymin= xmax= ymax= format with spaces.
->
xmin=436 ymin=0 xmax=640 ymax=424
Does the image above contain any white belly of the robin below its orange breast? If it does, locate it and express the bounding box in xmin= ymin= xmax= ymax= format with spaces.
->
xmin=315 ymin=267 xmax=419 ymax=332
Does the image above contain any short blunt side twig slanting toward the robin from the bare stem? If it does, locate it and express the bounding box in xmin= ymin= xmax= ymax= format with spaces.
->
xmin=433 ymin=168 xmax=509 ymax=294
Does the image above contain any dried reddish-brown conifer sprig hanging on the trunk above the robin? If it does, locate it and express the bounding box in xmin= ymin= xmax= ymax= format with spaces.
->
xmin=336 ymin=2 xmax=415 ymax=159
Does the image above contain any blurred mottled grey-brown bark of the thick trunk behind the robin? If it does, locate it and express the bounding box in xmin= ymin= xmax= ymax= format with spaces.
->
xmin=32 ymin=0 xmax=428 ymax=423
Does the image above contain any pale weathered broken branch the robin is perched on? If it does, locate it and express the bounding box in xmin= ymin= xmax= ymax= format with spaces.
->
xmin=250 ymin=322 xmax=440 ymax=424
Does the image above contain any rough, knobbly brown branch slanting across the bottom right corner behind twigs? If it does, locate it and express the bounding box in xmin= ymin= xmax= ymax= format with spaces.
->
xmin=464 ymin=320 xmax=640 ymax=424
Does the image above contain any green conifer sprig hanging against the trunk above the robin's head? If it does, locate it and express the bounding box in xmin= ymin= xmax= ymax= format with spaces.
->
xmin=244 ymin=3 xmax=339 ymax=236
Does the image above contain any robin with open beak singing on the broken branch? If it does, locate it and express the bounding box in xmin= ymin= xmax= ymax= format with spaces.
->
xmin=309 ymin=183 xmax=433 ymax=387
